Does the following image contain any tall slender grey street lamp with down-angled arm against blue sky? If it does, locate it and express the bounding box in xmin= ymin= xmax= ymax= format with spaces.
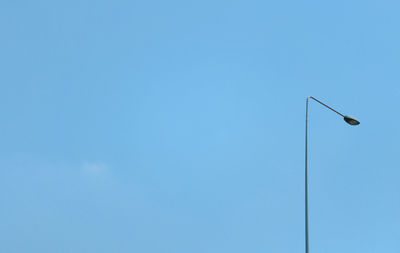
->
xmin=305 ymin=96 xmax=360 ymax=253
